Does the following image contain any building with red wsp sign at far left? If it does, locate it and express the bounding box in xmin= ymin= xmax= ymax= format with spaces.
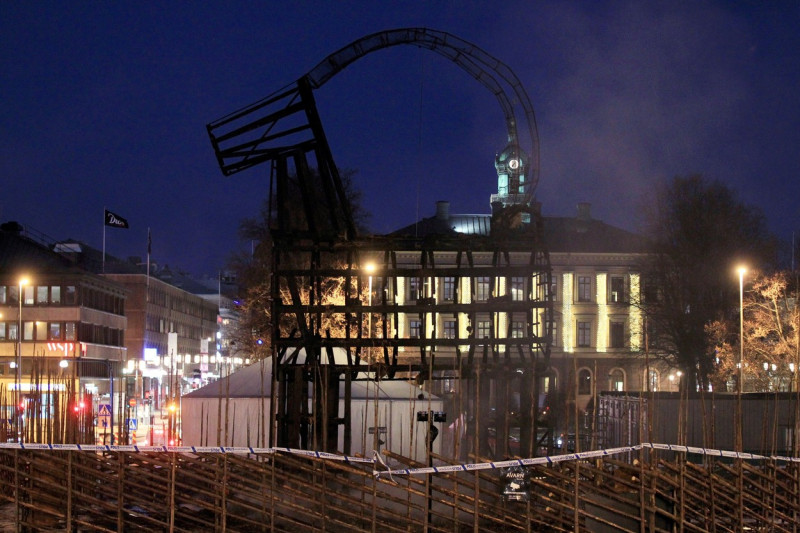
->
xmin=0 ymin=222 xmax=128 ymax=440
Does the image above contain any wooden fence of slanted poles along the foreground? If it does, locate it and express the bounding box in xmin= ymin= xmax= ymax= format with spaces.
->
xmin=0 ymin=449 xmax=800 ymax=533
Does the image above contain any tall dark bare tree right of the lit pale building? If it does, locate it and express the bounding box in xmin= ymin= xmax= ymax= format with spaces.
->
xmin=641 ymin=175 xmax=775 ymax=390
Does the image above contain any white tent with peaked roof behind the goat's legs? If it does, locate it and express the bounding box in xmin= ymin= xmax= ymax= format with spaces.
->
xmin=181 ymin=349 xmax=443 ymax=461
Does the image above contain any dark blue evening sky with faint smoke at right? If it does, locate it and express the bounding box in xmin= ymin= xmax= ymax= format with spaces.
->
xmin=0 ymin=1 xmax=800 ymax=274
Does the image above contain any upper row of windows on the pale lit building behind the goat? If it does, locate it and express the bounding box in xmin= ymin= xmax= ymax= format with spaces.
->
xmin=404 ymin=276 xmax=628 ymax=303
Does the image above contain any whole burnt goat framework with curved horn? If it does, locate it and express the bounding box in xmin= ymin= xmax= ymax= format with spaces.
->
xmin=207 ymin=28 xmax=552 ymax=455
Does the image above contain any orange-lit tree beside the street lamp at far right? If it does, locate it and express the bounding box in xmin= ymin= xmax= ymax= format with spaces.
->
xmin=709 ymin=271 xmax=800 ymax=391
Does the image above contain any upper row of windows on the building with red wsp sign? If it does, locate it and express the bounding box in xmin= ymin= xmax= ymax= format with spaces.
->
xmin=0 ymin=285 xmax=125 ymax=315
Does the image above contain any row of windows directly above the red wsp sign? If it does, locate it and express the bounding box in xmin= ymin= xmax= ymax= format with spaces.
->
xmin=0 ymin=321 xmax=125 ymax=346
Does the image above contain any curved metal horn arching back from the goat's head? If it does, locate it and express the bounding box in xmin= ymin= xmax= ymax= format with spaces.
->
xmin=304 ymin=28 xmax=539 ymax=196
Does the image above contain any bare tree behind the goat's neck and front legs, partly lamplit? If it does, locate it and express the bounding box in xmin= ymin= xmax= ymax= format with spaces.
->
xmin=230 ymin=170 xmax=369 ymax=358
